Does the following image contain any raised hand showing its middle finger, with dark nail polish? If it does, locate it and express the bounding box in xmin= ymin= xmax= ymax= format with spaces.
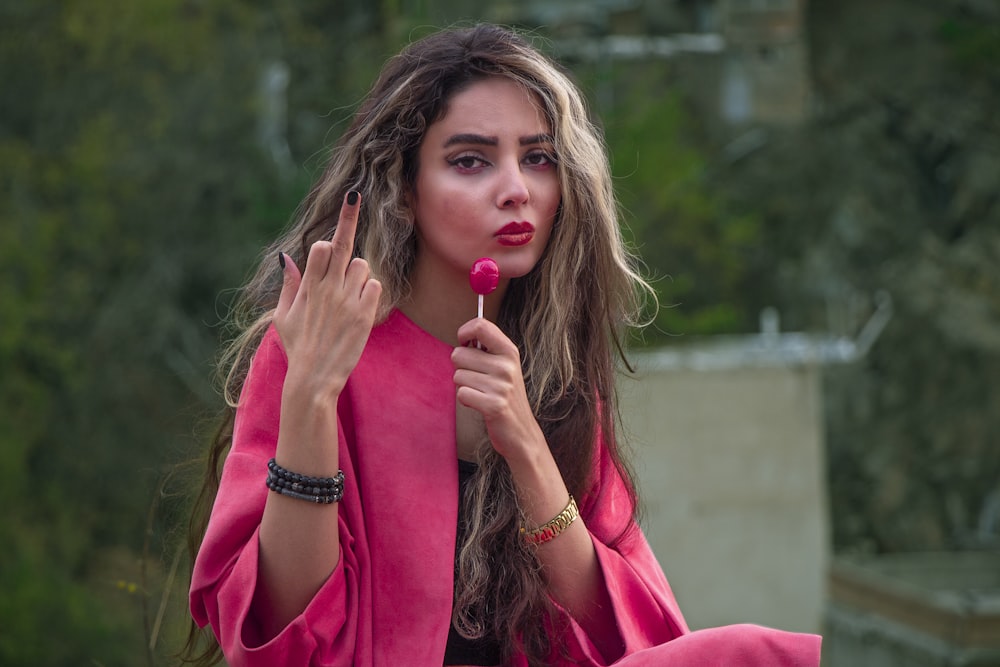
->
xmin=274 ymin=190 xmax=382 ymax=398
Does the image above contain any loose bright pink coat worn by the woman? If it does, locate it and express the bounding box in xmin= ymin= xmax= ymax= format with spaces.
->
xmin=190 ymin=311 xmax=820 ymax=667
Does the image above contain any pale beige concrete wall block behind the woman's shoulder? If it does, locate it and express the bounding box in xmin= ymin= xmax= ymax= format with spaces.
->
xmin=620 ymin=358 xmax=830 ymax=632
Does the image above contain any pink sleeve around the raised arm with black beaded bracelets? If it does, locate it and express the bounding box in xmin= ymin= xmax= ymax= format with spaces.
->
xmin=190 ymin=327 xmax=358 ymax=667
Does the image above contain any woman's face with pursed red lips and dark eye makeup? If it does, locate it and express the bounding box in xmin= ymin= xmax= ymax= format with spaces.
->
xmin=410 ymin=77 xmax=561 ymax=285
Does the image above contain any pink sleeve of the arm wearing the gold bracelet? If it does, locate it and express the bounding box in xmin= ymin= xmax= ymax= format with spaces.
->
xmin=548 ymin=436 xmax=820 ymax=667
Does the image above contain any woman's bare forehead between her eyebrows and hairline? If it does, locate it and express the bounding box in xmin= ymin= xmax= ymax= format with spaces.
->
xmin=427 ymin=77 xmax=551 ymax=136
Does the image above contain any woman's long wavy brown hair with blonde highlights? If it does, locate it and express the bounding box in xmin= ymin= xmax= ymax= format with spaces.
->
xmin=189 ymin=25 xmax=656 ymax=665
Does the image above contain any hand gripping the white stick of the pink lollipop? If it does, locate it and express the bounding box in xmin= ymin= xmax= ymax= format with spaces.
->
xmin=451 ymin=318 xmax=548 ymax=462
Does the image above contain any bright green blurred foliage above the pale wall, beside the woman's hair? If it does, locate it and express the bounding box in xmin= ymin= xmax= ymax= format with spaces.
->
xmin=608 ymin=87 xmax=759 ymax=344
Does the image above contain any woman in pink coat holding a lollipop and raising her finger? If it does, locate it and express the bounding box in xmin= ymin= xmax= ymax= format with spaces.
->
xmin=191 ymin=26 xmax=818 ymax=667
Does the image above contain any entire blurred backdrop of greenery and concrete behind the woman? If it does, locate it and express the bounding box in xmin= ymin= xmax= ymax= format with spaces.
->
xmin=0 ymin=0 xmax=1000 ymax=667
